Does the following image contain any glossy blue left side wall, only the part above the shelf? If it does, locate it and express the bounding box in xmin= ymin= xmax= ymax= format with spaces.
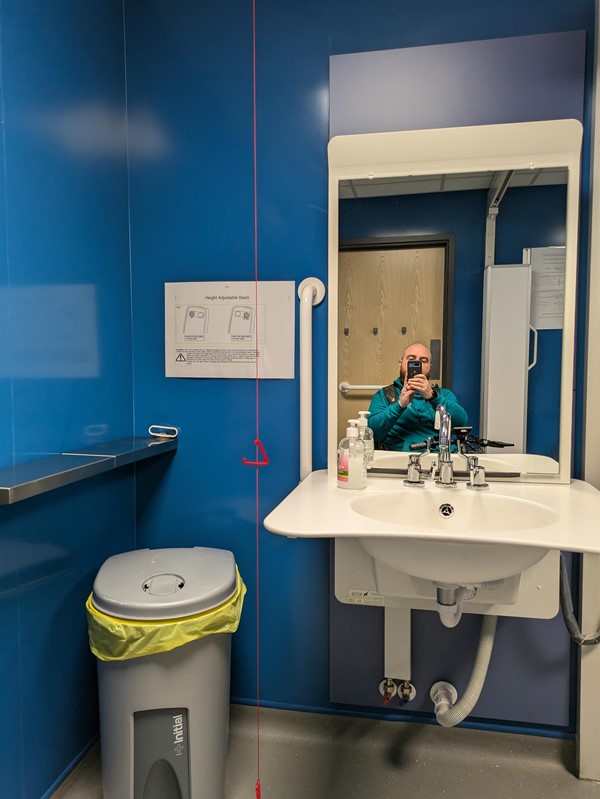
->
xmin=2 ymin=0 xmax=132 ymax=462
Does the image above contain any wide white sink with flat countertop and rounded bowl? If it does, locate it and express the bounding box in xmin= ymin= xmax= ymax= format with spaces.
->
xmin=264 ymin=471 xmax=600 ymax=585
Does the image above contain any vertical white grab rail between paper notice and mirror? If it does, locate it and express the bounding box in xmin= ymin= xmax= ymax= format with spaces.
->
xmin=298 ymin=277 xmax=325 ymax=480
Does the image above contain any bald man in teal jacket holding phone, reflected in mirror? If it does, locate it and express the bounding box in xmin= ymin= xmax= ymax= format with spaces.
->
xmin=369 ymin=343 xmax=467 ymax=450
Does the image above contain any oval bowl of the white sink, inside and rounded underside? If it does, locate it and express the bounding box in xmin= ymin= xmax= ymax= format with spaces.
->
xmin=350 ymin=489 xmax=557 ymax=585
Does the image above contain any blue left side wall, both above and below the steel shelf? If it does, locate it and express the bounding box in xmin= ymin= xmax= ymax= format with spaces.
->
xmin=0 ymin=0 xmax=135 ymax=799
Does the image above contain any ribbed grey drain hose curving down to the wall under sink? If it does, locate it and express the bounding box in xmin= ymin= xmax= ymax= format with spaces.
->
xmin=429 ymin=616 xmax=498 ymax=727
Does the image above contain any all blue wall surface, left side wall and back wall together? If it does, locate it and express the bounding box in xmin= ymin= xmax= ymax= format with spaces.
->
xmin=0 ymin=0 xmax=594 ymax=799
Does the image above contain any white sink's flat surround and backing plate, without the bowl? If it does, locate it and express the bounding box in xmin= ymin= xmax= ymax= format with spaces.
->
xmin=265 ymin=470 xmax=600 ymax=619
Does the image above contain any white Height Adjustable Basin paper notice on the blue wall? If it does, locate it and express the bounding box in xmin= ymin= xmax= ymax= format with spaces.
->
xmin=165 ymin=281 xmax=295 ymax=379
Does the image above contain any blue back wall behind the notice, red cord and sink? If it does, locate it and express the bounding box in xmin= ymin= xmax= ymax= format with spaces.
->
xmin=126 ymin=0 xmax=594 ymax=723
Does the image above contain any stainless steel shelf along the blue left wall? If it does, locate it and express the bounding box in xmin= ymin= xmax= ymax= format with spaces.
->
xmin=0 ymin=437 xmax=178 ymax=505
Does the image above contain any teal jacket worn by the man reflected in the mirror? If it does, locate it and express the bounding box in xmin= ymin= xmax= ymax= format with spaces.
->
xmin=369 ymin=378 xmax=467 ymax=450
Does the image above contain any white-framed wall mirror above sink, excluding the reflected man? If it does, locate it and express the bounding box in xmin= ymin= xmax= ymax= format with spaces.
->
xmin=328 ymin=120 xmax=582 ymax=482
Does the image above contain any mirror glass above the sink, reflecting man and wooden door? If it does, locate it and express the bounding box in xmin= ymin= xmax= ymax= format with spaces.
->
xmin=337 ymin=167 xmax=568 ymax=473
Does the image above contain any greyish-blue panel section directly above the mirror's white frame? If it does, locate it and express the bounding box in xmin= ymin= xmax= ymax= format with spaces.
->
xmin=330 ymin=31 xmax=585 ymax=137
